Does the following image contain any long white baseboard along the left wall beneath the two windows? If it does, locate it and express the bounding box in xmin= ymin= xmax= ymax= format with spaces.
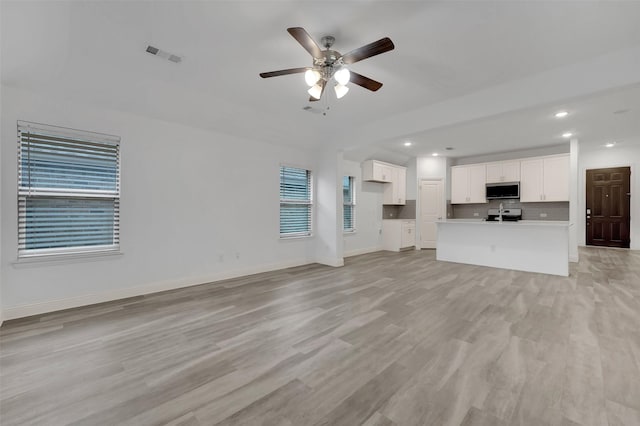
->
xmin=0 ymin=260 xmax=316 ymax=323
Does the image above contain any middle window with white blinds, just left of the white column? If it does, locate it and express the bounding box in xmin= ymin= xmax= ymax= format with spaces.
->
xmin=280 ymin=166 xmax=312 ymax=238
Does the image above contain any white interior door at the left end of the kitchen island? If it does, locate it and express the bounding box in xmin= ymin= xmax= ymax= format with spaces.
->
xmin=420 ymin=180 xmax=444 ymax=248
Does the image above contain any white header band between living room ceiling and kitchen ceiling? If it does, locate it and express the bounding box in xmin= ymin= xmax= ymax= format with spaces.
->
xmin=366 ymin=84 xmax=640 ymax=157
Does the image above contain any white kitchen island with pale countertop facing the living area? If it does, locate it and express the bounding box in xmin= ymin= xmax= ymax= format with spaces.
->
xmin=436 ymin=219 xmax=570 ymax=277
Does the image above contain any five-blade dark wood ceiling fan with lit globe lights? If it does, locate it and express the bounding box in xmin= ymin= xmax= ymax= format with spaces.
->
xmin=260 ymin=27 xmax=395 ymax=101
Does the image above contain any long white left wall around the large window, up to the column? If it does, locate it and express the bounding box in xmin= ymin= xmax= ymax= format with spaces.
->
xmin=0 ymin=87 xmax=320 ymax=318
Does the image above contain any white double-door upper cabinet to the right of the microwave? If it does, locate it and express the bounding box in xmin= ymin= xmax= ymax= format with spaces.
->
xmin=520 ymin=155 xmax=569 ymax=203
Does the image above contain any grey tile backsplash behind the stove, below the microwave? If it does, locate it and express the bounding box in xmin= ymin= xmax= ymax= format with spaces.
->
xmin=451 ymin=200 xmax=569 ymax=220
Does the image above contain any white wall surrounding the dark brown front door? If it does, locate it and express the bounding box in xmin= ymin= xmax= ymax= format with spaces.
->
xmin=577 ymin=141 xmax=640 ymax=250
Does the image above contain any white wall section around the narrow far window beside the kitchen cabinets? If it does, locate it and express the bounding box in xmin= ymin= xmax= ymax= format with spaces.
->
xmin=341 ymin=160 xmax=384 ymax=256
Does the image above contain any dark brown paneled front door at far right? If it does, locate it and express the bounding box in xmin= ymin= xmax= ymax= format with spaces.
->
xmin=585 ymin=167 xmax=631 ymax=248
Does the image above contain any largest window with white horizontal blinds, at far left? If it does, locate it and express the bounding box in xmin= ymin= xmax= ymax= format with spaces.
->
xmin=18 ymin=121 xmax=120 ymax=257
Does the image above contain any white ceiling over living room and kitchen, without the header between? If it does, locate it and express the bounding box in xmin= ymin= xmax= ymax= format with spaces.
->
xmin=1 ymin=0 xmax=640 ymax=156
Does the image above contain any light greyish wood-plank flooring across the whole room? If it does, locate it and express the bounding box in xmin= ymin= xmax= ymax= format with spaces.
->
xmin=0 ymin=248 xmax=640 ymax=426
